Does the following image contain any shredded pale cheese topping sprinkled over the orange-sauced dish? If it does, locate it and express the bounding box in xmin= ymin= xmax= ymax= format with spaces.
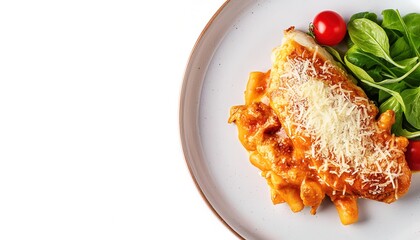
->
xmin=280 ymin=52 xmax=403 ymax=195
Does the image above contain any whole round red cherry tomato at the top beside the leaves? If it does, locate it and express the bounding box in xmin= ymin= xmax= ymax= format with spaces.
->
xmin=312 ymin=10 xmax=347 ymax=46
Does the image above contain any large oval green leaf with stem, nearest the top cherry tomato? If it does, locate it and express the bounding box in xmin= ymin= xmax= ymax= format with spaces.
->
xmin=347 ymin=18 xmax=404 ymax=68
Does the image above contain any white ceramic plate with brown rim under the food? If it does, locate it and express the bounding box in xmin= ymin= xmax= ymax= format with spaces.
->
xmin=180 ymin=0 xmax=420 ymax=239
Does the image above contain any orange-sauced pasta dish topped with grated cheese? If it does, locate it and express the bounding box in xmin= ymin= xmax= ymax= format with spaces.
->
xmin=228 ymin=27 xmax=411 ymax=225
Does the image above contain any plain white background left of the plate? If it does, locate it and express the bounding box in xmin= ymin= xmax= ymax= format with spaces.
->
xmin=0 ymin=0 xmax=236 ymax=239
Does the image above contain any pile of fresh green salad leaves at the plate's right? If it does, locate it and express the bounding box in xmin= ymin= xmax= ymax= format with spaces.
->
xmin=342 ymin=9 xmax=420 ymax=138
